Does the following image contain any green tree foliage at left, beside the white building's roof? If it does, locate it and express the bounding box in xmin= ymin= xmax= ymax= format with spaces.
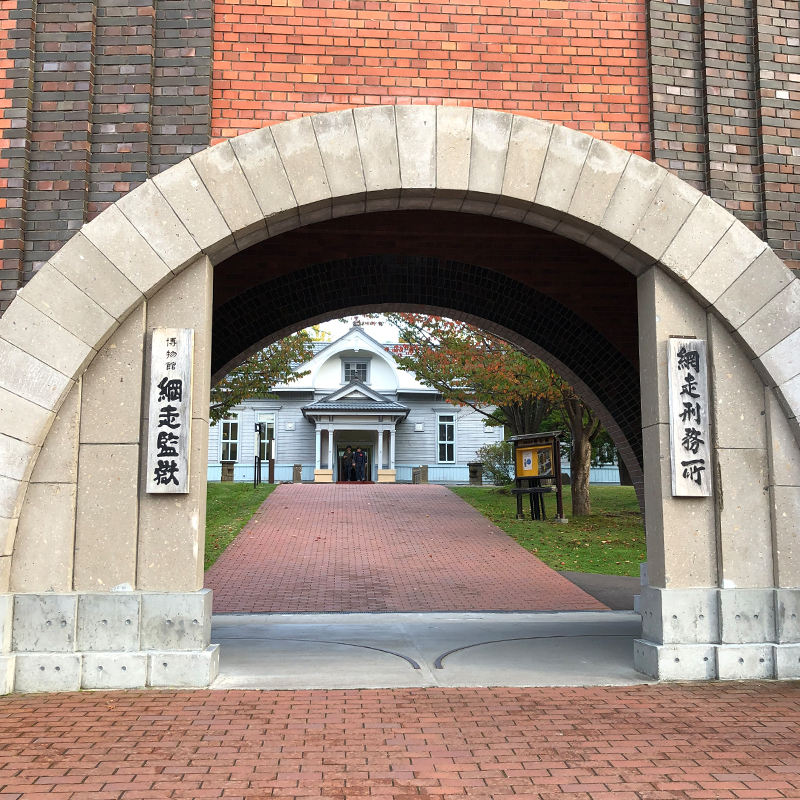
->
xmin=209 ymin=331 xmax=315 ymax=425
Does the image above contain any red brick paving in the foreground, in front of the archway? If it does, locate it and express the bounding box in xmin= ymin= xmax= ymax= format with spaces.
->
xmin=0 ymin=683 xmax=800 ymax=800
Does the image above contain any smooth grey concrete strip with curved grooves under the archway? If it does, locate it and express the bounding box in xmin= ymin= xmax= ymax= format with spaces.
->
xmin=212 ymin=611 xmax=648 ymax=689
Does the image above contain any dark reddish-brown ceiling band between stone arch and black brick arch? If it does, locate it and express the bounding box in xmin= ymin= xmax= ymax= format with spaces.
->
xmin=214 ymin=211 xmax=639 ymax=366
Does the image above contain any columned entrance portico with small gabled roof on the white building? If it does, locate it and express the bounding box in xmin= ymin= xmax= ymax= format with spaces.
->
xmin=303 ymin=379 xmax=411 ymax=483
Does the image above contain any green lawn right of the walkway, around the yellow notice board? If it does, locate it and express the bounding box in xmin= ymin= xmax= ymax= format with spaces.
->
xmin=453 ymin=486 xmax=647 ymax=577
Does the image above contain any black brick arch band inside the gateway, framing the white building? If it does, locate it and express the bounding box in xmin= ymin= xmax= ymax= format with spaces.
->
xmin=211 ymin=254 xmax=643 ymax=489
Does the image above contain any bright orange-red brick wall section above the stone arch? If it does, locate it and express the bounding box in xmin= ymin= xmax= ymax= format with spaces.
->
xmin=212 ymin=0 xmax=650 ymax=158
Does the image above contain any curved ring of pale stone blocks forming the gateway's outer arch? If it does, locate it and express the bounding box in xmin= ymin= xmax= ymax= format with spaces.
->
xmin=0 ymin=106 xmax=800 ymax=674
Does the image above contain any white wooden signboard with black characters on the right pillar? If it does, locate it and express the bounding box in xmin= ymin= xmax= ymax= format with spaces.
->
xmin=667 ymin=337 xmax=712 ymax=497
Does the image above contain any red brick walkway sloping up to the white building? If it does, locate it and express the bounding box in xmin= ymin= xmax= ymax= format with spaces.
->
xmin=205 ymin=484 xmax=605 ymax=613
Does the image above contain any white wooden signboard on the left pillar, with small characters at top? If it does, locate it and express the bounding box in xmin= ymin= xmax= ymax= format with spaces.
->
xmin=146 ymin=328 xmax=194 ymax=494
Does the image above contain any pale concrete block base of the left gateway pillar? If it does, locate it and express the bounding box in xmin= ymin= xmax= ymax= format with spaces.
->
xmin=0 ymin=589 xmax=219 ymax=694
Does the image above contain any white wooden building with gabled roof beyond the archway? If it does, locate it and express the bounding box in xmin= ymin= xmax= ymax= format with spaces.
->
xmin=208 ymin=326 xmax=503 ymax=484
